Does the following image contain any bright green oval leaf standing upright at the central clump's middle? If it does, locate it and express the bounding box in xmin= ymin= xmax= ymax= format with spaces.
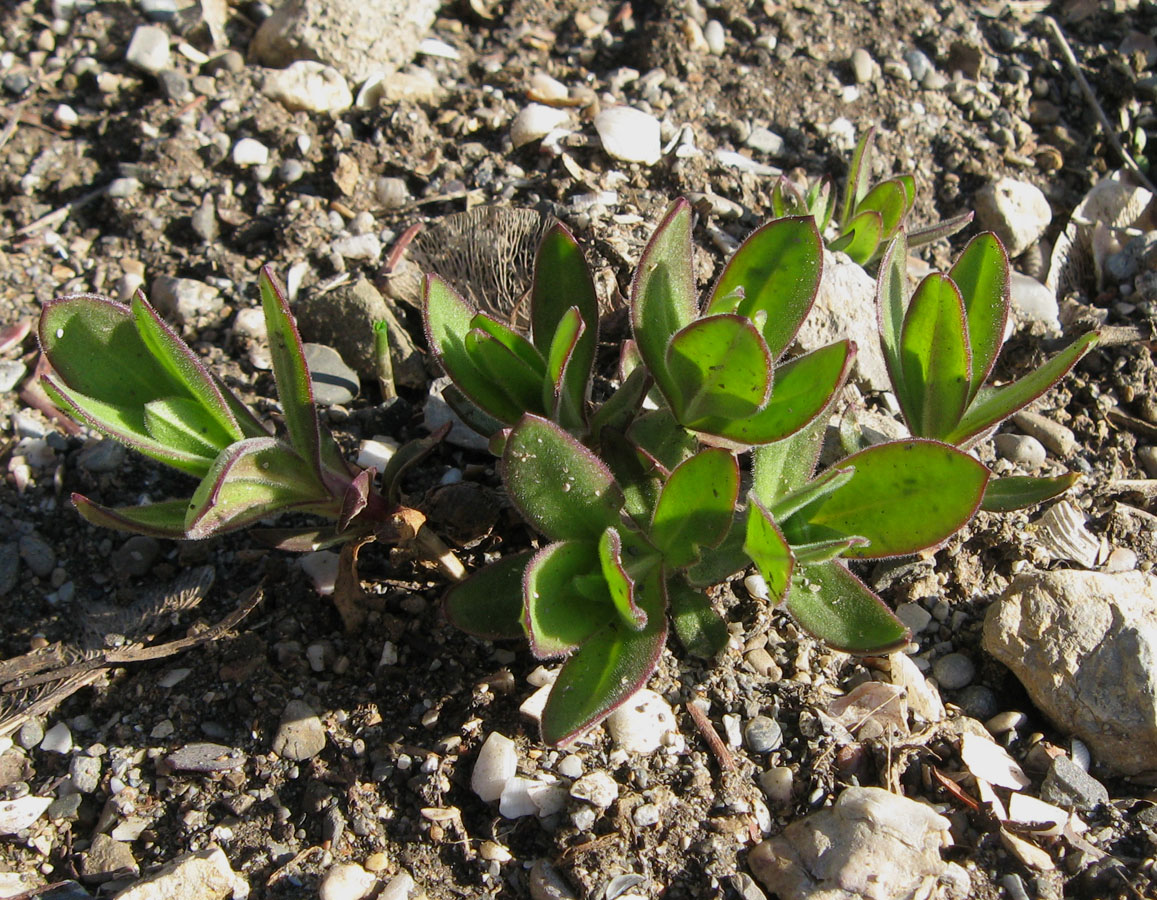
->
xmin=650 ymin=448 xmax=739 ymax=568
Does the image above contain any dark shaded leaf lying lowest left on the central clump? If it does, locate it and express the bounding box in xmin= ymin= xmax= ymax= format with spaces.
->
xmin=442 ymin=549 xmax=533 ymax=641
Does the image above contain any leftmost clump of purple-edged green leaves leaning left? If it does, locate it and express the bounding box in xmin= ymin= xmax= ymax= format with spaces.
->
xmin=39 ymin=268 xmax=446 ymax=624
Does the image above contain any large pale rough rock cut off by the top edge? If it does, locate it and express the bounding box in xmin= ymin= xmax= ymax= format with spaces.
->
xmin=250 ymin=0 xmax=441 ymax=83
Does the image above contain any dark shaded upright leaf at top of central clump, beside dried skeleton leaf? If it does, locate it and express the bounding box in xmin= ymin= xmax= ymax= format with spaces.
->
xmin=530 ymin=223 xmax=598 ymax=421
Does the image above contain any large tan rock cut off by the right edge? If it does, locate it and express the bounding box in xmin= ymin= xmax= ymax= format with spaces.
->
xmin=983 ymin=569 xmax=1157 ymax=783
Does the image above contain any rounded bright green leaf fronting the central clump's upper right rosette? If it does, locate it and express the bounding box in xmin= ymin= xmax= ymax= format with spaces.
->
xmin=666 ymin=316 xmax=772 ymax=427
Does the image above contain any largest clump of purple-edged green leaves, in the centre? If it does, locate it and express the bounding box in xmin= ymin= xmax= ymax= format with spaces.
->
xmin=423 ymin=200 xmax=1088 ymax=745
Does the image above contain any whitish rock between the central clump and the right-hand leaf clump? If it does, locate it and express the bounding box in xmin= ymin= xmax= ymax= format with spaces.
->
xmin=796 ymin=250 xmax=891 ymax=391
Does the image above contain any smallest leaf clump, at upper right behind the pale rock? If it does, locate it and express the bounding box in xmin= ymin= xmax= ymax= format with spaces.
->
xmin=772 ymin=128 xmax=972 ymax=266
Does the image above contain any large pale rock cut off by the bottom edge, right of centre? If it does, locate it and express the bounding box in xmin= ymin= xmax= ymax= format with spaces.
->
xmin=747 ymin=788 xmax=970 ymax=900
